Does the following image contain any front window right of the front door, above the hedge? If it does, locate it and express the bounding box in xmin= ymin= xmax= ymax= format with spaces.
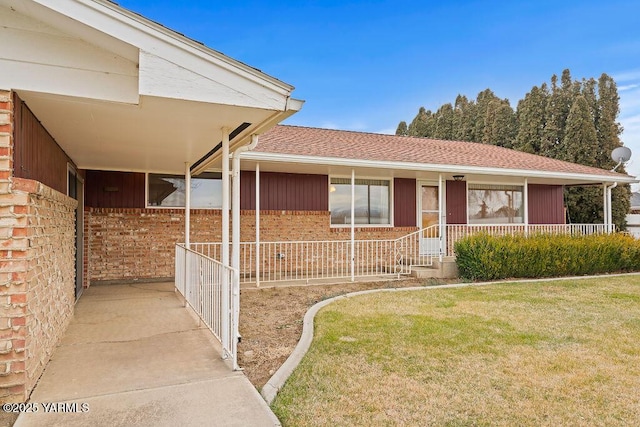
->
xmin=467 ymin=184 xmax=524 ymax=224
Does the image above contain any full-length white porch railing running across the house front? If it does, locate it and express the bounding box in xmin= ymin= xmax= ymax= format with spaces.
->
xmin=184 ymin=224 xmax=607 ymax=283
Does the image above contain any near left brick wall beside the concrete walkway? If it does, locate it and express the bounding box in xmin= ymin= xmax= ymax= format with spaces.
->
xmin=0 ymin=91 xmax=77 ymax=402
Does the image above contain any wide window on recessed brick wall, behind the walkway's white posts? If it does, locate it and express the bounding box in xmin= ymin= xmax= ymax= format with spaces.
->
xmin=147 ymin=172 xmax=222 ymax=209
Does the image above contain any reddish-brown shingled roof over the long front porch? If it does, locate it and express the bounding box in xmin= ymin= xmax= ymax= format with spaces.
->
xmin=255 ymin=125 xmax=630 ymax=179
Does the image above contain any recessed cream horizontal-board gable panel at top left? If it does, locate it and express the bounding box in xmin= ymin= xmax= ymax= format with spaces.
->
xmin=0 ymin=6 xmax=138 ymax=103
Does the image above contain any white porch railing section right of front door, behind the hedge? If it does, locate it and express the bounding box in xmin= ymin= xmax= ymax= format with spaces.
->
xmin=443 ymin=224 xmax=608 ymax=256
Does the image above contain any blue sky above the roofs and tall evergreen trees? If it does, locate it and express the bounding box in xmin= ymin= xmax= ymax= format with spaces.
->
xmin=118 ymin=0 xmax=640 ymax=184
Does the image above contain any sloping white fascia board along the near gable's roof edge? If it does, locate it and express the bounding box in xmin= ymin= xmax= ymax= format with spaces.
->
xmin=33 ymin=0 xmax=293 ymax=110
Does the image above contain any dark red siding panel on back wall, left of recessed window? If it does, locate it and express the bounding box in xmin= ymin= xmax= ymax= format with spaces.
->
xmin=85 ymin=170 xmax=145 ymax=208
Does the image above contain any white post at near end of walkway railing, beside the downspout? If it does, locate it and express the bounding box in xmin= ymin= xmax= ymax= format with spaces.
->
xmin=220 ymin=127 xmax=232 ymax=356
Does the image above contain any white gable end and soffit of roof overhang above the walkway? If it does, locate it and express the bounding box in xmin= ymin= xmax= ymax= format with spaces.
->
xmin=0 ymin=0 xmax=302 ymax=173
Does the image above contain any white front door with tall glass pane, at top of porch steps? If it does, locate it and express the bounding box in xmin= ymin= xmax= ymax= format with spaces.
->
xmin=419 ymin=184 xmax=440 ymax=255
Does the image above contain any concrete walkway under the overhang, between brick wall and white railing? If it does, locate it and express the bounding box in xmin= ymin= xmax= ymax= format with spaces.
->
xmin=15 ymin=283 xmax=279 ymax=427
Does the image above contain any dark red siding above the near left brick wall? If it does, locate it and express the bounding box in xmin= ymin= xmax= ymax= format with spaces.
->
xmin=13 ymin=92 xmax=75 ymax=194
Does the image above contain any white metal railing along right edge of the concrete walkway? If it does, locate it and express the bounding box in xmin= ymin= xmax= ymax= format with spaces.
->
xmin=175 ymin=244 xmax=239 ymax=369
